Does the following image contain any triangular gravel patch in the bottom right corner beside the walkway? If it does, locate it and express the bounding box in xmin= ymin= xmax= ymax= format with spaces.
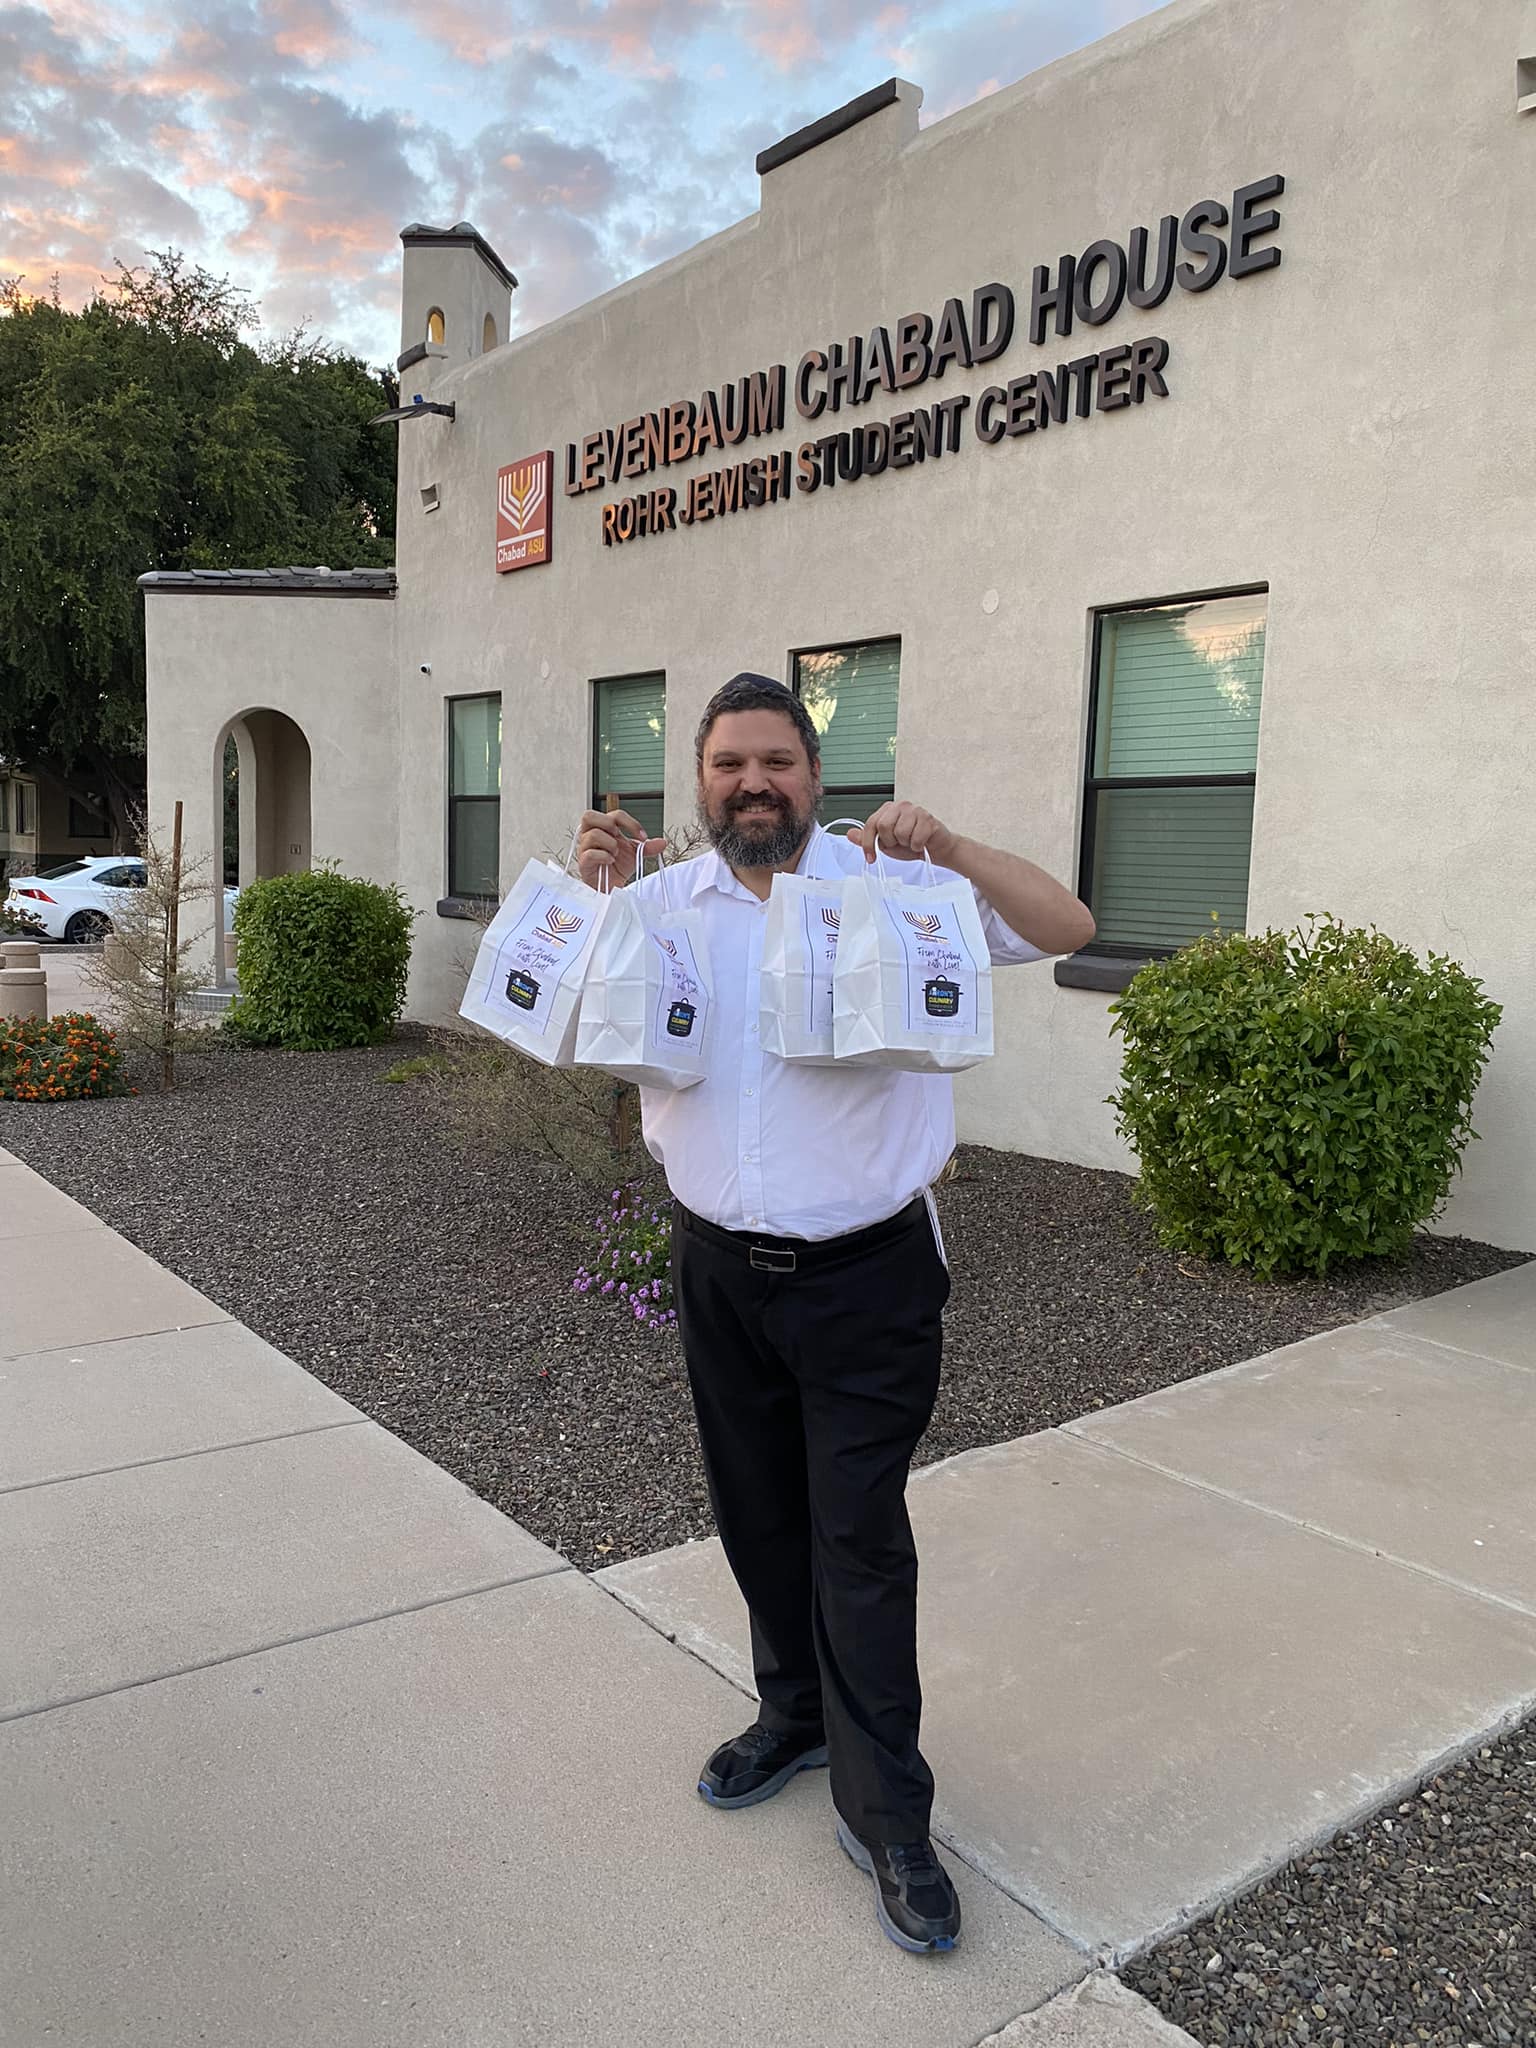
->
xmin=1122 ymin=1720 xmax=1536 ymax=2048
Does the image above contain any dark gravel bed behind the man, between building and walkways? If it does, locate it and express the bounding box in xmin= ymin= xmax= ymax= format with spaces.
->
xmin=0 ymin=1036 xmax=1520 ymax=1569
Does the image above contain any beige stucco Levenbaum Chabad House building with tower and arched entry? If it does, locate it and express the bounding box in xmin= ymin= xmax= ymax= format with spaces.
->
xmin=145 ymin=0 xmax=1536 ymax=1247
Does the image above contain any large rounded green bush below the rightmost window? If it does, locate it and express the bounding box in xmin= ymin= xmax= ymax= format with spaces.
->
xmin=1110 ymin=918 xmax=1501 ymax=1276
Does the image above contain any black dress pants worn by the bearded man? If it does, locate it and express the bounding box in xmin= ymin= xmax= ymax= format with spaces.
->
xmin=672 ymin=1202 xmax=948 ymax=1841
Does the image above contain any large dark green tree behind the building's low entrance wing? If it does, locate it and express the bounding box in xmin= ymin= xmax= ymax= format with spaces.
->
xmin=0 ymin=250 xmax=399 ymax=844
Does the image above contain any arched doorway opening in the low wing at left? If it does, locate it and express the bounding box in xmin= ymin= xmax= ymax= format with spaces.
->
xmin=211 ymin=707 xmax=311 ymax=987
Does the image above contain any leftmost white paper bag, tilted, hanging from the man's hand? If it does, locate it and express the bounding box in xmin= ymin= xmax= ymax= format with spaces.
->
xmin=459 ymin=860 xmax=612 ymax=1067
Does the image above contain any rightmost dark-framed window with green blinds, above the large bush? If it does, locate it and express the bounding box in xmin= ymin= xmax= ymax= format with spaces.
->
xmin=1079 ymin=592 xmax=1266 ymax=956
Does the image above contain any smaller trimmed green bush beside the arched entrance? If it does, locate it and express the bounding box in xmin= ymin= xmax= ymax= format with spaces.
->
xmin=229 ymin=866 xmax=414 ymax=1053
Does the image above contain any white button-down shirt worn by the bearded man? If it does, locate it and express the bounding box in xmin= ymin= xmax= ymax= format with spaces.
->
xmin=641 ymin=827 xmax=1044 ymax=1241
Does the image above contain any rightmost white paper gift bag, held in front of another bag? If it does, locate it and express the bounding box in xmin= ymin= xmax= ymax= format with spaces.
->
xmin=831 ymin=858 xmax=991 ymax=1073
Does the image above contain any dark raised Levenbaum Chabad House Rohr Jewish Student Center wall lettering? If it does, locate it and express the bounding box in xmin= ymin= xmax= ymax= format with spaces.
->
xmin=507 ymin=172 xmax=1286 ymax=569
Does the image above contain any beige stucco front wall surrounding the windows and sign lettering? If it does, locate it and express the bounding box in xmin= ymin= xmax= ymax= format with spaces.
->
xmin=152 ymin=0 xmax=1536 ymax=1245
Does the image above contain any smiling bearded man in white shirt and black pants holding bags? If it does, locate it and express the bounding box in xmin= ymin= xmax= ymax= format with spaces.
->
xmin=580 ymin=674 xmax=1094 ymax=1954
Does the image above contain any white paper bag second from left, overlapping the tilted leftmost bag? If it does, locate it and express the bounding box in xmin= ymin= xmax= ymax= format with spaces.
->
xmin=575 ymin=874 xmax=713 ymax=1090
